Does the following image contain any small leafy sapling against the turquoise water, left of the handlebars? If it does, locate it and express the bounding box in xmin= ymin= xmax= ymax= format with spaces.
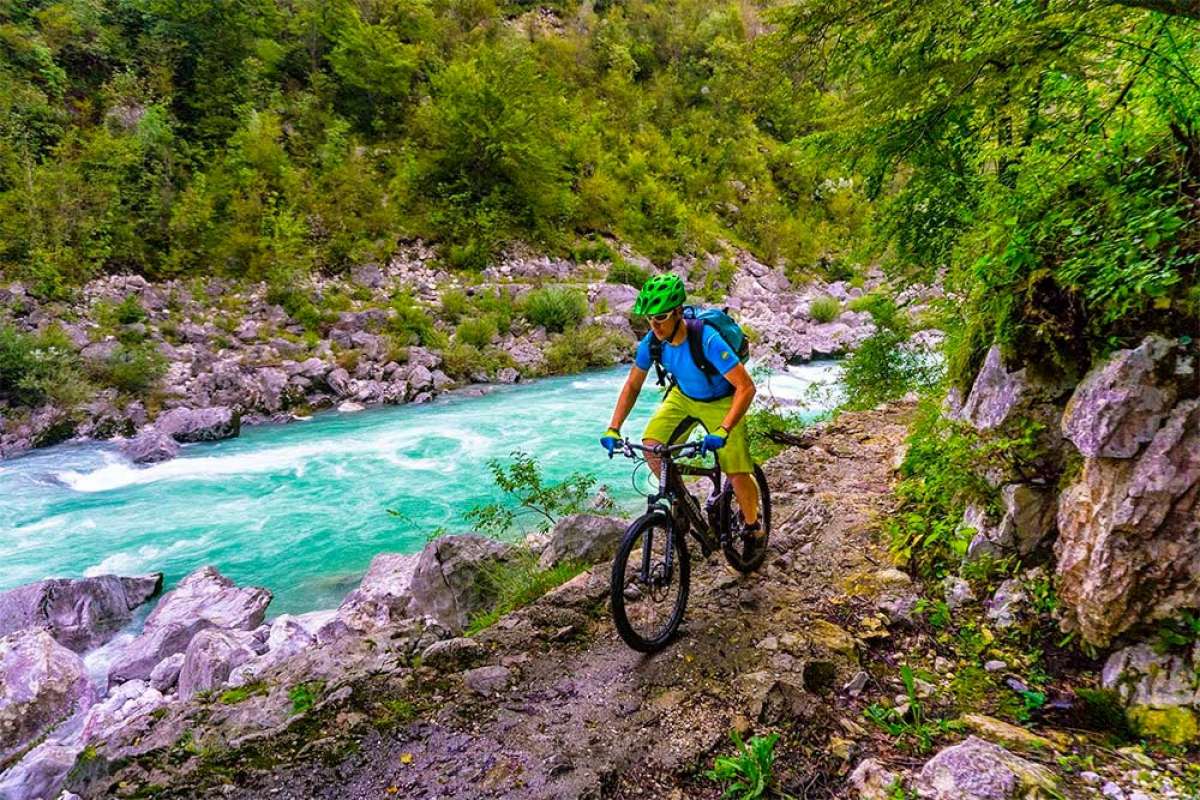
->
xmin=464 ymin=450 xmax=596 ymax=536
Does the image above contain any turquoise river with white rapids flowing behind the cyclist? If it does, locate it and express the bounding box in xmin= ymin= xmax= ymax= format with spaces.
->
xmin=0 ymin=362 xmax=836 ymax=615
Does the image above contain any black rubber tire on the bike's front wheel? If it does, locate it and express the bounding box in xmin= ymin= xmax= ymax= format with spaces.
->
xmin=610 ymin=511 xmax=691 ymax=652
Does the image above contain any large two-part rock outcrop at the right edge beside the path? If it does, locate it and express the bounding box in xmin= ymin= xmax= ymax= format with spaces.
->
xmin=1055 ymin=337 xmax=1200 ymax=645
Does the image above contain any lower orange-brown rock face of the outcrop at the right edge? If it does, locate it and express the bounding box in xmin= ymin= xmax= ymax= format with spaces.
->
xmin=1055 ymin=399 xmax=1200 ymax=646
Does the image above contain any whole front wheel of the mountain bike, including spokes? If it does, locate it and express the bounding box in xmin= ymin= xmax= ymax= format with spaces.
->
xmin=612 ymin=512 xmax=691 ymax=652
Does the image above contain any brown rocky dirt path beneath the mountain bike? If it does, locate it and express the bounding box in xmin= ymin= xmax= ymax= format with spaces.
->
xmin=229 ymin=408 xmax=907 ymax=800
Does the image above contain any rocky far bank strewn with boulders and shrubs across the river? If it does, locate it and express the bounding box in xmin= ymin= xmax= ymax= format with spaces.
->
xmin=0 ymin=245 xmax=938 ymax=463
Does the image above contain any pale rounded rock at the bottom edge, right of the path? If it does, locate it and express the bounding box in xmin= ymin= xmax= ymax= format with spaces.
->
xmin=917 ymin=736 xmax=1058 ymax=800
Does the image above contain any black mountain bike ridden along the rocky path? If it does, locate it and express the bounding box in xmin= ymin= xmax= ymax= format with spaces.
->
xmin=611 ymin=439 xmax=770 ymax=652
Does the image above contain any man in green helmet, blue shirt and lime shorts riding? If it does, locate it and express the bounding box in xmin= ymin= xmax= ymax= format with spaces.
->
xmin=600 ymin=275 xmax=762 ymax=536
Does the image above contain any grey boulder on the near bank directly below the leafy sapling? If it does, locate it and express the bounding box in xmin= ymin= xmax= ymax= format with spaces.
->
xmin=407 ymin=534 xmax=511 ymax=633
